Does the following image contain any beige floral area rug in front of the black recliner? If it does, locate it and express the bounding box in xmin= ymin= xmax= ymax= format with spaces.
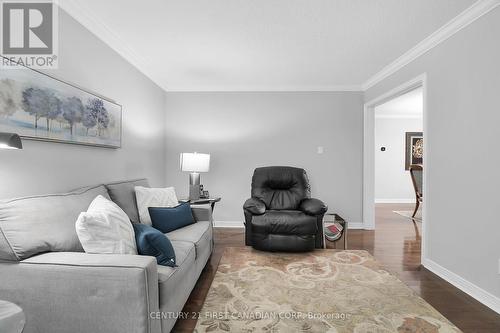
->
xmin=195 ymin=247 xmax=460 ymax=333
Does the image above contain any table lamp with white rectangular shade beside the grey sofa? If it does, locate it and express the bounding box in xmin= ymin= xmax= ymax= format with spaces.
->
xmin=180 ymin=153 xmax=210 ymax=200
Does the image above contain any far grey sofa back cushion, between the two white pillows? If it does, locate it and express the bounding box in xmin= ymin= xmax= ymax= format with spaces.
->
xmin=105 ymin=179 xmax=149 ymax=223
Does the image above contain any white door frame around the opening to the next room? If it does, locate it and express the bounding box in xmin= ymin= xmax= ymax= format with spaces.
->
xmin=363 ymin=73 xmax=429 ymax=261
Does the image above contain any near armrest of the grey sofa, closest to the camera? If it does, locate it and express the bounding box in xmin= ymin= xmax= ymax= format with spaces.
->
xmin=0 ymin=252 xmax=161 ymax=333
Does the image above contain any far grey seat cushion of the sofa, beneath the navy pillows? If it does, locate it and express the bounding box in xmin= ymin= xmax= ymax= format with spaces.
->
xmin=166 ymin=221 xmax=212 ymax=259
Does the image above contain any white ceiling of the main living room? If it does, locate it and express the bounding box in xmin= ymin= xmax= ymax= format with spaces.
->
xmin=60 ymin=0 xmax=475 ymax=91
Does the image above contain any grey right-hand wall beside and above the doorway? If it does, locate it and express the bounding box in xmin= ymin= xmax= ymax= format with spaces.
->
xmin=365 ymin=7 xmax=500 ymax=297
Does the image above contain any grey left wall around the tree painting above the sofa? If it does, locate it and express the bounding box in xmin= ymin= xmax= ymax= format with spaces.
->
xmin=0 ymin=11 xmax=165 ymax=198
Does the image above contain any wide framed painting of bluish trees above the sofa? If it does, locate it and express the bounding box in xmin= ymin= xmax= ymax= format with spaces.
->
xmin=0 ymin=57 xmax=122 ymax=149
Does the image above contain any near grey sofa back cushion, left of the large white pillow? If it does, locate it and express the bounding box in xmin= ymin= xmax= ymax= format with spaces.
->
xmin=0 ymin=185 xmax=109 ymax=260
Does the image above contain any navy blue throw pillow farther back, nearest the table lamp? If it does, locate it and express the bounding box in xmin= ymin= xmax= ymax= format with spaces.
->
xmin=148 ymin=202 xmax=194 ymax=233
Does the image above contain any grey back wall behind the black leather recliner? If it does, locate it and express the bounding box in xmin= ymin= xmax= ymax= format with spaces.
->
xmin=166 ymin=92 xmax=363 ymax=222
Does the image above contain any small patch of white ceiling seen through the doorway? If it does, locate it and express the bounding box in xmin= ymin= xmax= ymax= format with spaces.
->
xmin=375 ymin=88 xmax=424 ymax=118
